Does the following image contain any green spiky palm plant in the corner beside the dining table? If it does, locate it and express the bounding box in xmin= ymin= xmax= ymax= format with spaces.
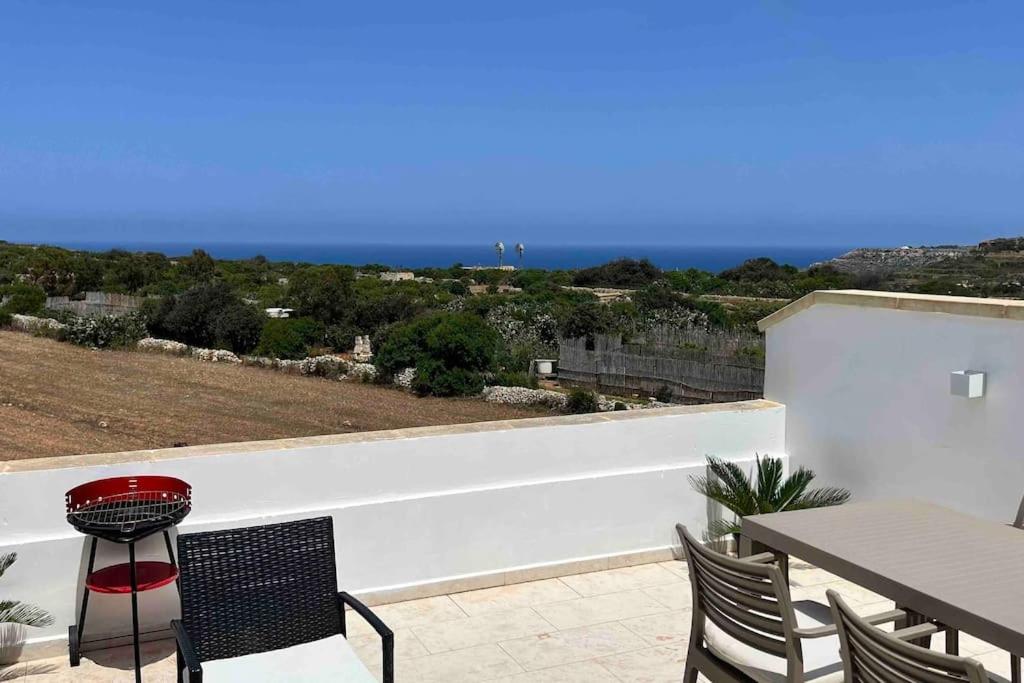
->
xmin=690 ymin=455 xmax=850 ymax=549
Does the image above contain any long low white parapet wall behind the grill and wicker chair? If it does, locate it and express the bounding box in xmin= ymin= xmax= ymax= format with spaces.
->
xmin=0 ymin=400 xmax=785 ymax=658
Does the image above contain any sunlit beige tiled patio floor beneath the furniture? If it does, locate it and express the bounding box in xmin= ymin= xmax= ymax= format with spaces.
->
xmin=0 ymin=561 xmax=1009 ymax=683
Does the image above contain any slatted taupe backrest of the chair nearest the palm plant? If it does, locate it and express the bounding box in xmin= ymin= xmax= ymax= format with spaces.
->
xmin=676 ymin=524 xmax=803 ymax=681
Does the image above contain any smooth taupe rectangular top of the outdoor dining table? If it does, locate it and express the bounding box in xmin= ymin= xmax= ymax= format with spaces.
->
xmin=742 ymin=500 xmax=1024 ymax=654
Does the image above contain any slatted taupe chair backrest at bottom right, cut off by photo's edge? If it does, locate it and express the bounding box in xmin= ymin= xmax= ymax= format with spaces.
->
xmin=827 ymin=591 xmax=988 ymax=683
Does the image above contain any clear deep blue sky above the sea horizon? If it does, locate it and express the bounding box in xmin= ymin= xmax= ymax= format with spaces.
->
xmin=0 ymin=0 xmax=1024 ymax=245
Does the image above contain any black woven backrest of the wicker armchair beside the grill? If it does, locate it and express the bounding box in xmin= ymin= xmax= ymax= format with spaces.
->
xmin=178 ymin=517 xmax=341 ymax=661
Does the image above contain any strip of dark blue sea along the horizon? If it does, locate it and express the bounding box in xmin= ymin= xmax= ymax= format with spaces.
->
xmin=60 ymin=242 xmax=852 ymax=272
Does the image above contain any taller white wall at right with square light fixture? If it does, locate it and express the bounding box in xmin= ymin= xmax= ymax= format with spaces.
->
xmin=761 ymin=291 xmax=1024 ymax=522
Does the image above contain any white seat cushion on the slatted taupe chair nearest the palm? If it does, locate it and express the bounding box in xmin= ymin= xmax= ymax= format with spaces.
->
xmin=705 ymin=600 xmax=843 ymax=683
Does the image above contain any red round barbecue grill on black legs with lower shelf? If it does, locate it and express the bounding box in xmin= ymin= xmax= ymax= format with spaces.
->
xmin=65 ymin=476 xmax=191 ymax=681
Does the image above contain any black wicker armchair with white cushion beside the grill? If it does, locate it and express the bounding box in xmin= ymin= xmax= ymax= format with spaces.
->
xmin=171 ymin=517 xmax=394 ymax=683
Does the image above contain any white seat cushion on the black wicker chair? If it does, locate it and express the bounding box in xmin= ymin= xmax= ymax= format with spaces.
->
xmin=203 ymin=635 xmax=377 ymax=683
